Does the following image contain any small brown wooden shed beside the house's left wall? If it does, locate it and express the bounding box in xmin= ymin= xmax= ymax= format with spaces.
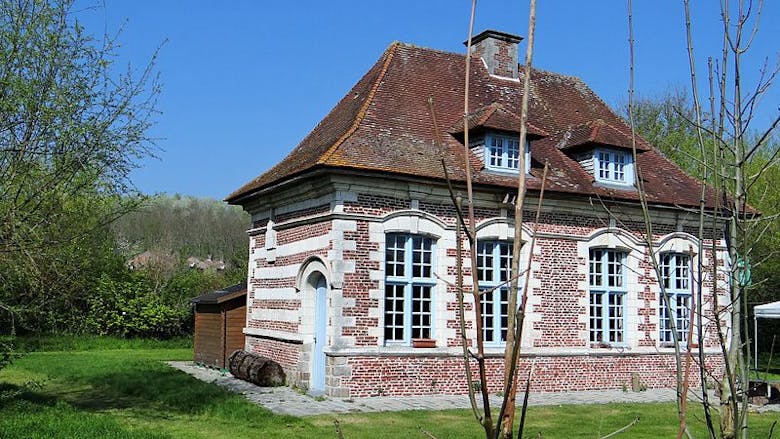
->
xmin=192 ymin=284 xmax=246 ymax=368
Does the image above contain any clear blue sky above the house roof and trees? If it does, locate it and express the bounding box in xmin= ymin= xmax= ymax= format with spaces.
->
xmin=76 ymin=0 xmax=780 ymax=199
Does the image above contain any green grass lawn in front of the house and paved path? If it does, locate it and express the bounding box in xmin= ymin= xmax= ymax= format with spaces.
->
xmin=0 ymin=337 xmax=780 ymax=439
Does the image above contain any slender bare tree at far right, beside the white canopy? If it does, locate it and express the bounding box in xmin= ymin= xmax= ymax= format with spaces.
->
xmin=684 ymin=0 xmax=780 ymax=438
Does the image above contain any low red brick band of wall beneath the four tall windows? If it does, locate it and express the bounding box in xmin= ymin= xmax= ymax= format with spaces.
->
xmin=342 ymin=354 xmax=721 ymax=397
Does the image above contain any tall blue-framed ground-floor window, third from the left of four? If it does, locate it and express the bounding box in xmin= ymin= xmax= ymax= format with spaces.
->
xmin=589 ymin=249 xmax=627 ymax=345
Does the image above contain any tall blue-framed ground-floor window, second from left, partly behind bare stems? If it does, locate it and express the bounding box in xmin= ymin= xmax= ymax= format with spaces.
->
xmin=477 ymin=241 xmax=512 ymax=345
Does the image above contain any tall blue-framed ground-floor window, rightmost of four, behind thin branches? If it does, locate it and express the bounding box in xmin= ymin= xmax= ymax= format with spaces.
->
xmin=658 ymin=253 xmax=691 ymax=345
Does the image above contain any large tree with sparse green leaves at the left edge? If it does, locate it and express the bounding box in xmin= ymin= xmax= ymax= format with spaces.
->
xmin=0 ymin=0 xmax=159 ymax=329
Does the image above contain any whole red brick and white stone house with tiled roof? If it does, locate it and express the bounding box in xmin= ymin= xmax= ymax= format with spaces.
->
xmin=227 ymin=31 xmax=727 ymax=397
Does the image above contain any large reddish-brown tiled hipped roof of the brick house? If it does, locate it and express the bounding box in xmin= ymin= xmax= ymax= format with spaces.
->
xmin=227 ymin=43 xmax=714 ymax=210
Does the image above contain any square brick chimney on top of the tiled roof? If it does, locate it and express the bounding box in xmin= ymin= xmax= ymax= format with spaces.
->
xmin=463 ymin=30 xmax=523 ymax=78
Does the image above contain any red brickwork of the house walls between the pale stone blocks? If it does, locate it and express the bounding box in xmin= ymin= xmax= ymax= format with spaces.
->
xmin=247 ymin=189 xmax=723 ymax=397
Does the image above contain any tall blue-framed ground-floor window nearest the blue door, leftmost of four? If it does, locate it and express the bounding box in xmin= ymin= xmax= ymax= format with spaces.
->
xmin=385 ymin=233 xmax=436 ymax=345
